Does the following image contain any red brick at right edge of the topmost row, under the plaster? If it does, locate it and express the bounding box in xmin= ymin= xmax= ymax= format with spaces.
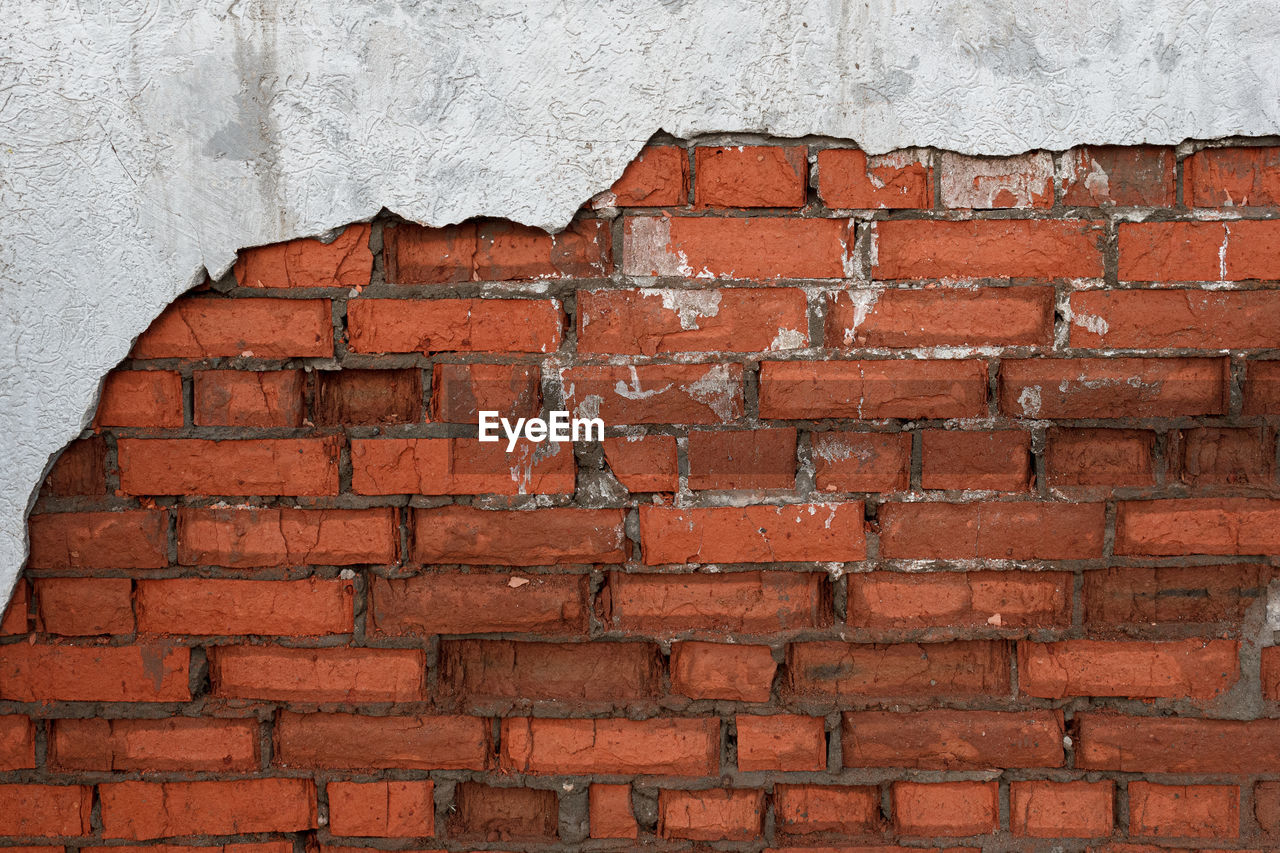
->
xmin=1183 ymin=146 xmax=1280 ymax=207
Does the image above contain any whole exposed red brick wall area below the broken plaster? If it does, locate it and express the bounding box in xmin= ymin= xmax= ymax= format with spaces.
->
xmin=0 ymin=140 xmax=1280 ymax=853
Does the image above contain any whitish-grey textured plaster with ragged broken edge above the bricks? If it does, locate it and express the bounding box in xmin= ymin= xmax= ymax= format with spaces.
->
xmin=0 ymin=0 xmax=1280 ymax=599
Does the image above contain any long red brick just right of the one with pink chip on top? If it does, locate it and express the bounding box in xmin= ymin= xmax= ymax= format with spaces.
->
xmin=605 ymin=571 xmax=831 ymax=637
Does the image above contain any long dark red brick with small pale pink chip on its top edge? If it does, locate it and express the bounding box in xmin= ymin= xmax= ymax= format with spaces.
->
xmin=370 ymin=573 xmax=590 ymax=637
